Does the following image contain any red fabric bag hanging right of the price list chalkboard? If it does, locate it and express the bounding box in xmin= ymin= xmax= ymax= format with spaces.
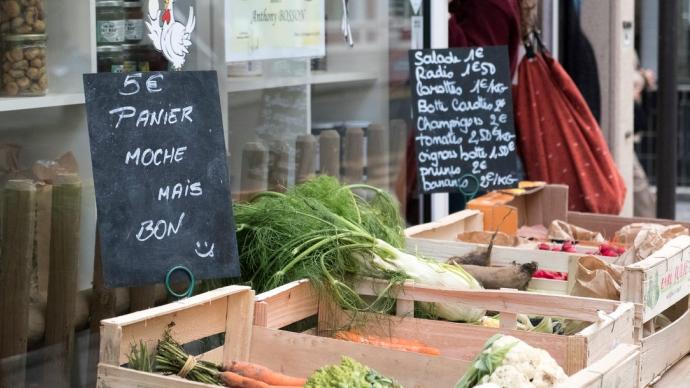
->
xmin=514 ymin=50 xmax=626 ymax=214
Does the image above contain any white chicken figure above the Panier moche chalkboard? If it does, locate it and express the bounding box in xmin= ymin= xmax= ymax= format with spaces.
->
xmin=146 ymin=0 xmax=196 ymax=70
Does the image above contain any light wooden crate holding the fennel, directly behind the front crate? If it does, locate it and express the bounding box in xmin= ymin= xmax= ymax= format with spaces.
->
xmin=254 ymin=281 xmax=634 ymax=374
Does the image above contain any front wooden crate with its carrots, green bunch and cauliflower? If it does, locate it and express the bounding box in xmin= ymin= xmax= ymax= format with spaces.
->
xmin=97 ymin=286 xmax=636 ymax=388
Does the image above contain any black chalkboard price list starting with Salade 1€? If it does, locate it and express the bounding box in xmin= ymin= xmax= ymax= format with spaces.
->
xmin=410 ymin=46 xmax=518 ymax=193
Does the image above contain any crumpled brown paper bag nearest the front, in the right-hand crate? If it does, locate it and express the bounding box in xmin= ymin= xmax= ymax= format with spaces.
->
xmin=570 ymin=256 xmax=623 ymax=300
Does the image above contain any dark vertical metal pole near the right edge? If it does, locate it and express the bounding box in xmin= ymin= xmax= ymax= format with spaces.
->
xmin=656 ymin=0 xmax=679 ymax=219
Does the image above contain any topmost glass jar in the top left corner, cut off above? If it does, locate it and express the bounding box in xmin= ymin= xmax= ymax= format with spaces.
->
xmin=0 ymin=0 xmax=46 ymax=34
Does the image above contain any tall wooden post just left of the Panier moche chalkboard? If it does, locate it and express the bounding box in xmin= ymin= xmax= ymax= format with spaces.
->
xmin=44 ymin=174 xmax=81 ymax=387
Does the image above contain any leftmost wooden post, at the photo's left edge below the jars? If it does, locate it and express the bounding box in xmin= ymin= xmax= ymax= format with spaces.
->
xmin=0 ymin=180 xmax=36 ymax=388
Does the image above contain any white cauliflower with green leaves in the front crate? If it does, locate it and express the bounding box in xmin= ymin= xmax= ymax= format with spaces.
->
xmin=456 ymin=334 xmax=568 ymax=388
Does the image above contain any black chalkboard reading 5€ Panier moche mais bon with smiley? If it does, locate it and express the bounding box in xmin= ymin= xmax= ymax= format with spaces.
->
xmin=84 ymin=71 xmax=240 ymax=287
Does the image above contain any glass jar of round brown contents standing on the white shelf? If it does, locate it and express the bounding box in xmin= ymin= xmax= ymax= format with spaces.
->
xmin=2 ymin=34 xmax=48 ymax=96
